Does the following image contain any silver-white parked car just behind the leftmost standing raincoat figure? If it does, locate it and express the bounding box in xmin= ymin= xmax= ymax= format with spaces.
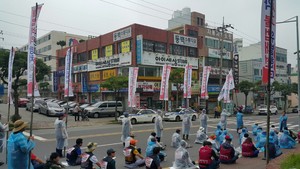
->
xmin=39 ymin=102 xmax=65 ymax=116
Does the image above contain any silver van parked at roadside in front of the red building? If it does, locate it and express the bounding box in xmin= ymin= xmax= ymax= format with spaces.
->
xmin=84 ymin=101 xmax=123 ymax=118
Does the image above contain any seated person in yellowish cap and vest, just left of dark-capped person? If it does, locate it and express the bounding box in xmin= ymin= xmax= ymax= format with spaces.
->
xmin=80 ymin=142 xmax=101 ymax=169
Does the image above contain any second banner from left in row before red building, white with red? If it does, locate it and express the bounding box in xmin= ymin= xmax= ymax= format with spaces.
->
xmin=159 ymin=65 xmax=171 ymax=100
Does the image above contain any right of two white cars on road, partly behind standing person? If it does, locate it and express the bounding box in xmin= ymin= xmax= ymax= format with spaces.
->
xmin=163 ymin=108 xmax=198 ymax=121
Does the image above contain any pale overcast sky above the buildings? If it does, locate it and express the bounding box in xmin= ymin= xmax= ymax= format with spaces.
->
xmin=0 ymin=0 xmax=300 ymax=66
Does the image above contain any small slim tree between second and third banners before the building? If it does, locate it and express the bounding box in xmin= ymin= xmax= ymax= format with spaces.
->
xmin=169 ymin=68 xmax=184 ymax=108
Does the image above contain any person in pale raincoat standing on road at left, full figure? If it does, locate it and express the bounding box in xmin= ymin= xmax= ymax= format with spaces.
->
xmin=54 ymin=113 xmax=68 ymax=157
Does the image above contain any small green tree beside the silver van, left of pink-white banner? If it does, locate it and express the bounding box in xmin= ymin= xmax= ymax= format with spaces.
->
xmin=100 ymin=76 xmax=128 ymax=121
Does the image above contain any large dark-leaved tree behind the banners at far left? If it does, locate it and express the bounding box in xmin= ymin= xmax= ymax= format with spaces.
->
xmin=0 ymin=49 xmax=51 ymax=122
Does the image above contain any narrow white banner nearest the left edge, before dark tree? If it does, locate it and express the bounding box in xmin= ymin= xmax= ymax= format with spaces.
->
xmin=7 ymin=47 xmax=16 ymax=104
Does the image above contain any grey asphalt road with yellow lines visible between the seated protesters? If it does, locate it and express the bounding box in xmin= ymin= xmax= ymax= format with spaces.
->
xmin=0 ymin=104 xmax=298 ymax=169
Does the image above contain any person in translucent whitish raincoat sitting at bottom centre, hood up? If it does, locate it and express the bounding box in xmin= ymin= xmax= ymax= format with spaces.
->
xmin=173 ymin=140 xmax=197 ymax=169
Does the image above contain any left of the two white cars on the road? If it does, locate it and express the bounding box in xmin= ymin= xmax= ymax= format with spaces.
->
xmin=118 ymin=109 xmax=157 ymax=124
